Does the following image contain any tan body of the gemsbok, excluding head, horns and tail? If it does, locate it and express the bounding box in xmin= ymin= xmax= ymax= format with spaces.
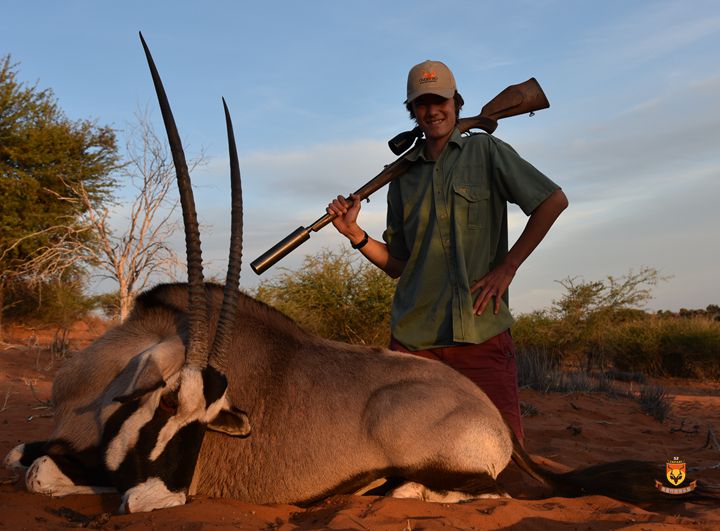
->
xmin=32 ymin=284 xmax=513 ymax=503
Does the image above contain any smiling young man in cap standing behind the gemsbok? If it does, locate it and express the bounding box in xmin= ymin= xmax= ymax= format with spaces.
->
xmin=327 ymin=61 xmax=568 ymax=442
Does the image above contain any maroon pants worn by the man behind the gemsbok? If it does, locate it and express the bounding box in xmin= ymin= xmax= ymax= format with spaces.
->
xmin=390 ymin=330 xmax=525 ymax=444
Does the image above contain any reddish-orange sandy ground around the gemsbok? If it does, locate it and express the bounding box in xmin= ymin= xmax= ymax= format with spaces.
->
xmin=0 ymin=325 xmax=720 ymax=531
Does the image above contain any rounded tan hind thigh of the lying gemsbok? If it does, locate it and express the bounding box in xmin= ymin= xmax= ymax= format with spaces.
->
xmin=364 ymin=381 xmax=513 ymax=482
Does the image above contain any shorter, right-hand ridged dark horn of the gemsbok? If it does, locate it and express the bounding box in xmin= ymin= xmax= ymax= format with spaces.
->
xmin=208 ymin=98 xmax=243 ymax=373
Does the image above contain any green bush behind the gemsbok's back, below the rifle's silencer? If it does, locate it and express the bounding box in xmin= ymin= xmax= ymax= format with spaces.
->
xmin=256 ymin=246 xmax=395 ymax=345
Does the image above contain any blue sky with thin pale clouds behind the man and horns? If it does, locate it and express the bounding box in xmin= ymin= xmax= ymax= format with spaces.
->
xmin=5 ymin=0 xmax=720 ymax=312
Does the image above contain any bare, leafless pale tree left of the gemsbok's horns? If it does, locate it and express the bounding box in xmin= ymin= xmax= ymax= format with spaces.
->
xmin=68 ymin=112 xmax=204 ymax=320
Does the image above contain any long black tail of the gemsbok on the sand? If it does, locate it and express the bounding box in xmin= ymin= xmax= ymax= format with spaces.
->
xmin=512 ymin=437 xmax=720 ymax=503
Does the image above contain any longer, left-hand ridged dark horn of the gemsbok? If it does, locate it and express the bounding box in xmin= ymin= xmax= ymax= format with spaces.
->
xmin=140 ymin=33 xmax=208 ymax=368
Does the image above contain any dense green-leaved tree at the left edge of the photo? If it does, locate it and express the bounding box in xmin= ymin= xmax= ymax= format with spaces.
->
xmin=0 ymin=55 xmax=117 ymax=340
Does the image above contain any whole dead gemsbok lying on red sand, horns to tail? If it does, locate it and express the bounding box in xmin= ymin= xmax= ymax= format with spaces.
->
xmin=5 ymin=35 xmax=713 ymax=512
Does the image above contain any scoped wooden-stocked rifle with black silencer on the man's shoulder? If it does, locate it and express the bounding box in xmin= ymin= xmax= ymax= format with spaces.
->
xmin=250 ymin=77 xmax=550 ymax=275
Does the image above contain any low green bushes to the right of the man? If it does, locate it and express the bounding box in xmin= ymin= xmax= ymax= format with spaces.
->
xmin=513 ymin=268 xmax=720 ymax=385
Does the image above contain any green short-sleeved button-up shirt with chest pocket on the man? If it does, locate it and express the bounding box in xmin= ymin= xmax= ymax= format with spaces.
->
xmin=383 ymin=129 xmax=559 ymax=350
